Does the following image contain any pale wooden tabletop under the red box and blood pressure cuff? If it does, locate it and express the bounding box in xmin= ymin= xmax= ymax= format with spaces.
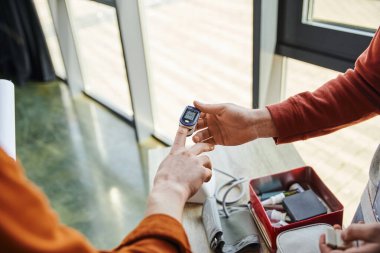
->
xmin=149 ymin=138 xmax=304 ymax=253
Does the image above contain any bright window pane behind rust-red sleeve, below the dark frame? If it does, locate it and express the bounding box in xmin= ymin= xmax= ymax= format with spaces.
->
xmin=285 ymin=58 xmax=380 ymax=225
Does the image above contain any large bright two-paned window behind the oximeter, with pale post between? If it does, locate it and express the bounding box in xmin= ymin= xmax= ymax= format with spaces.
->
xmin=36 ymin=0 xmax=253 ymax=143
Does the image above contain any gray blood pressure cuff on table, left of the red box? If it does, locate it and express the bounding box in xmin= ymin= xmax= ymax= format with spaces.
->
xmin=202 ymin=197 xmax=260 ymax=253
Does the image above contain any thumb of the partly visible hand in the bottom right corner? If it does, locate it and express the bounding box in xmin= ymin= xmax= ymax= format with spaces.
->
xmin=342 ymin=224 xmax=380 ymax=242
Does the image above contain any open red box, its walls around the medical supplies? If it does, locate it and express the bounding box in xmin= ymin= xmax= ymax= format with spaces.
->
xmin=249 ymin=167 xmax=343 ymax=252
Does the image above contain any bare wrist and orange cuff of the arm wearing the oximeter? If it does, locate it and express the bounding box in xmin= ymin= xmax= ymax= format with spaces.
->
xmin=104 ymin=180 xmax=191 ymax=253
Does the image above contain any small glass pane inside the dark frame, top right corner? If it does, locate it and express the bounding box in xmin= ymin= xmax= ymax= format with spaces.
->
xmin=311 ymin=0 xmax=380 ymax=30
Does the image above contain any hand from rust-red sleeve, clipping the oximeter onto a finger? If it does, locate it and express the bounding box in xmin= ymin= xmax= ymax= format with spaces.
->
xmin=193 ymin=101 xmax=277 ymax=146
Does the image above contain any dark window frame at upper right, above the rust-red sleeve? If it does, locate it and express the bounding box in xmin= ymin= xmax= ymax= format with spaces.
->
xmin=276 ymin=0 xmax=374 ymax=72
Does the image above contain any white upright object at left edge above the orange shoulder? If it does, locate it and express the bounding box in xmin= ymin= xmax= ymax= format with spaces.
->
xmin=0 ymin=79 xmax=16 ymax=160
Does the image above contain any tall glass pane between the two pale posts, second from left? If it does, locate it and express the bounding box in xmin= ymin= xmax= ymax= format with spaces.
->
xmin=69 ymin=0 xmax=132 ymax=115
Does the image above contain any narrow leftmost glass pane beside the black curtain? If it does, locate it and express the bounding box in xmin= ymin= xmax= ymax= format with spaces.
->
xmin=34 ymin=0 xmax=66 ymax=79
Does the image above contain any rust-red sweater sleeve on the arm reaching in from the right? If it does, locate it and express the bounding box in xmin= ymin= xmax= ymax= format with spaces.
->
xmin=267 ymin=29 xmax=380 ymax=143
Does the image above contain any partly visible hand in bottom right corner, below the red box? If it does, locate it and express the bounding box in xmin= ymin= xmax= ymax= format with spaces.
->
xmin=319 ymin=223 xmax=380 ymax=253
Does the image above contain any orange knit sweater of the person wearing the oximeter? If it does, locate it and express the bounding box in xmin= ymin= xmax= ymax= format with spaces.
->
xmin=0 ymin=149 xmax=190 ymax=253
